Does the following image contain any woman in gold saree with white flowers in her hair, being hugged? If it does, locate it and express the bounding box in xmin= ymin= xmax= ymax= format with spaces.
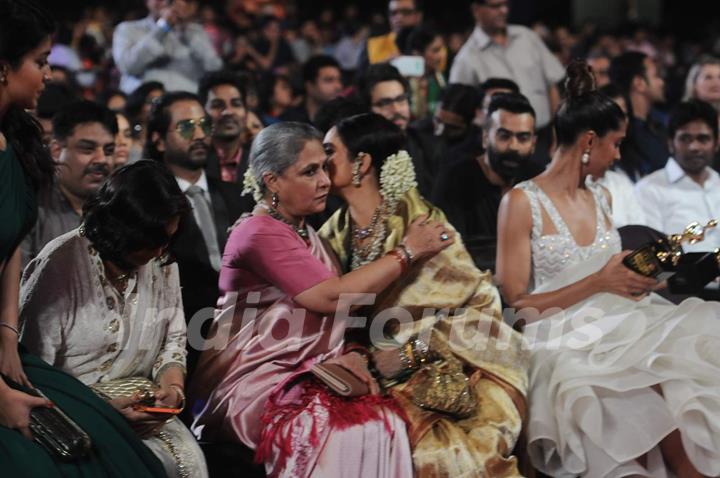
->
xmin=320 ymin=114 xmax=527 ymax=477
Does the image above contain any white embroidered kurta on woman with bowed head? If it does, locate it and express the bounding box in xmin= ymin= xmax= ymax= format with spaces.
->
xmin=20 ymin=229 xmax=207 ymax=477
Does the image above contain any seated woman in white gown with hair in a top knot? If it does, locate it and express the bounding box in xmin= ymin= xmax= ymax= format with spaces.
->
xmin=497 ymin=62 xmax=720 ymax=478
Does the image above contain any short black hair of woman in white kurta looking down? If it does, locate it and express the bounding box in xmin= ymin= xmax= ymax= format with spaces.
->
xmin=83 ymin=160 xmax=191 ymax=270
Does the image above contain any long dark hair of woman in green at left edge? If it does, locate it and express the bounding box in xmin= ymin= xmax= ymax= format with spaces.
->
xmin=0 ymin=0 xmax=55 ymax=188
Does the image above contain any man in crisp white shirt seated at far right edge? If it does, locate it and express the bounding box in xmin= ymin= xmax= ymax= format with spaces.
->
xmin=636 ymin=100 xmax=720 ymax=252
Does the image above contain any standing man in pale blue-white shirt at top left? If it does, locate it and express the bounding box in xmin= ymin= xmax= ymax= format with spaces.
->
xmin=113 ymin=0 xmax=222 ymax=94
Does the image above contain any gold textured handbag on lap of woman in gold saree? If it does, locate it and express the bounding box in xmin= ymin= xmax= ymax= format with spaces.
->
xmin=408 ymin=358 xmax=477 ymax=418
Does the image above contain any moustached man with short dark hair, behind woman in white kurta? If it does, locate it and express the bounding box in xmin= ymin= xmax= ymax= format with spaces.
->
xmin=21 ymin=101 xmax=118 ymax=267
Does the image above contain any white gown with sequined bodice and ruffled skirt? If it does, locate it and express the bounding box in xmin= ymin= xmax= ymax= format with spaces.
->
xmin=516 ymin=181 xmax=720 ymax=477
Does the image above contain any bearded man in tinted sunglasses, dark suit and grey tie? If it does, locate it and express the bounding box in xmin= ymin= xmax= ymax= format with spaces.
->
xmin=145 ymin=92 xmax=252 ymax=371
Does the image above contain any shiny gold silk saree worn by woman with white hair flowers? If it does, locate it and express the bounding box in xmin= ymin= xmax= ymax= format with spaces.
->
xmin=320 ymin=189 xmax=529 ymax=477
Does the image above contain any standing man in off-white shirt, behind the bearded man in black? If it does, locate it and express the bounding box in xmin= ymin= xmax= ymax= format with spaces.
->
xmin=450 ymin=0 xmax=565 ymax=164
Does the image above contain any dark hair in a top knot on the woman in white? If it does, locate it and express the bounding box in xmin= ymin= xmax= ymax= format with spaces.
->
xmin=555 ymin=60 xmax=625 ymax=146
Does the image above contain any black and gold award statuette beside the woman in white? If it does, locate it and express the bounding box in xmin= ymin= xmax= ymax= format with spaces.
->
xmin=623 ymin=219 xmax=717 ymax=282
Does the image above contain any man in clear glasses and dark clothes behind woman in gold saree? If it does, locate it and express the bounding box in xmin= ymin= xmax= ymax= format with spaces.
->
xmin=359 ymin=63 xmax=446 ymax=197
